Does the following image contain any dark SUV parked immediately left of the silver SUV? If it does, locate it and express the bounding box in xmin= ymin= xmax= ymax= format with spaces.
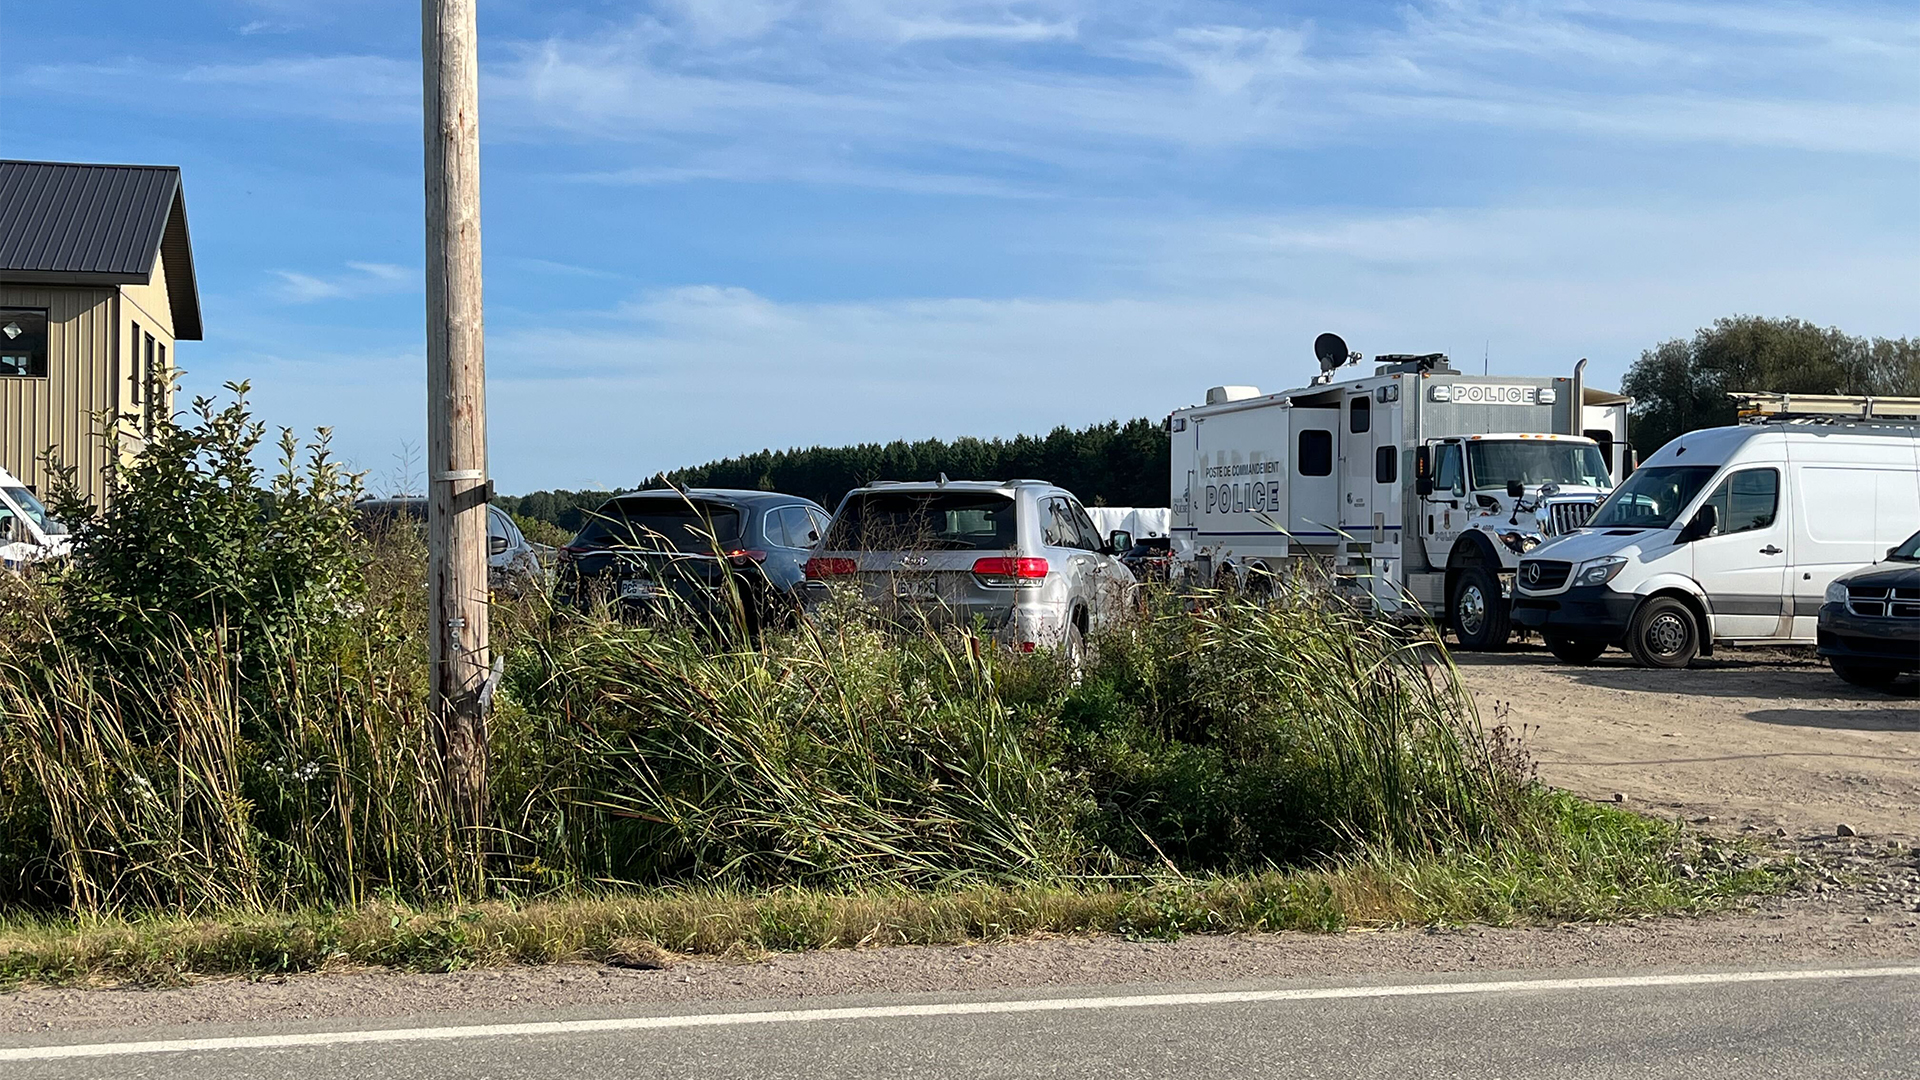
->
xmin=557 ymin=488 xmax=828 ymax=630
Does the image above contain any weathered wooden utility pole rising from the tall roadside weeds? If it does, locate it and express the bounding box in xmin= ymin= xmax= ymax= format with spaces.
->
xmin=420 ymin=0 xmax=492 ymax=828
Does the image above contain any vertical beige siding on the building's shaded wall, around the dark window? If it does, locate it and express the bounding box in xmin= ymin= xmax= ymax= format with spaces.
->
xmin=0 ymin=284 xmax=121 ymax=500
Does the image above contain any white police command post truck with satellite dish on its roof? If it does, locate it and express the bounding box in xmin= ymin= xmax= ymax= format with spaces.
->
xmin=1167 ymin=334 xmax=1632 ymax=650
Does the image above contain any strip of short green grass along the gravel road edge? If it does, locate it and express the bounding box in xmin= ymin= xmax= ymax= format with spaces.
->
xmin=0 ymin=796 xmax=1793 ymax=988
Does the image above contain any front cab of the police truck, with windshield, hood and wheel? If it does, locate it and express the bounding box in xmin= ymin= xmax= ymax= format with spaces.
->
xmin=1415 ymin=432 xmax=1613 ymax=650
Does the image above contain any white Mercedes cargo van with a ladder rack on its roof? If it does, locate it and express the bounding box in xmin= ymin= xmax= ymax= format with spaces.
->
xmin=1513 ymin=394 xmax=1920 ymax=667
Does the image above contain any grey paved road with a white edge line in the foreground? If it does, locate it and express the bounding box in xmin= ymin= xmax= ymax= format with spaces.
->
xmin=0 ymin=965 xmax=1920 ymax=1080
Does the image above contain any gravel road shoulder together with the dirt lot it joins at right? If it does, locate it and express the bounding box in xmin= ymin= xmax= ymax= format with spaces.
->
xmin=0 ymin=650 xmax=1920 ymax=1034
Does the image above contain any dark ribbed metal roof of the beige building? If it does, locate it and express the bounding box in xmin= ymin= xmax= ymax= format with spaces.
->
xmin=0 ymin=160 xmax=202 ymax=340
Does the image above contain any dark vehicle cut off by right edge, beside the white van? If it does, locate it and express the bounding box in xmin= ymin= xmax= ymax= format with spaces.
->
xmin=1820 ymin=532 xmax=1920 ymax=686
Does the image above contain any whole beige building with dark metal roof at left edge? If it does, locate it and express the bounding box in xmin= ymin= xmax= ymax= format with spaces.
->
xmin=0 ymin=160 xmax=202 ymax=500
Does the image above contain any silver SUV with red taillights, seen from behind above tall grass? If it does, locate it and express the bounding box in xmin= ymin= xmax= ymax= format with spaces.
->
xmin=806 ymin=479 xmax=1139 ymax=665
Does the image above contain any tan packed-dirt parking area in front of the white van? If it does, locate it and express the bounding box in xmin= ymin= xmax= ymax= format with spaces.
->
xmin=1455 ymin=648 xmax=1920 ymax=842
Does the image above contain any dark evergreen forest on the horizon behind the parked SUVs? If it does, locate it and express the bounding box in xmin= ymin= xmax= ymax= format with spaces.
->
xmin=493 ymin=419 xmax=1169 ymax=532
